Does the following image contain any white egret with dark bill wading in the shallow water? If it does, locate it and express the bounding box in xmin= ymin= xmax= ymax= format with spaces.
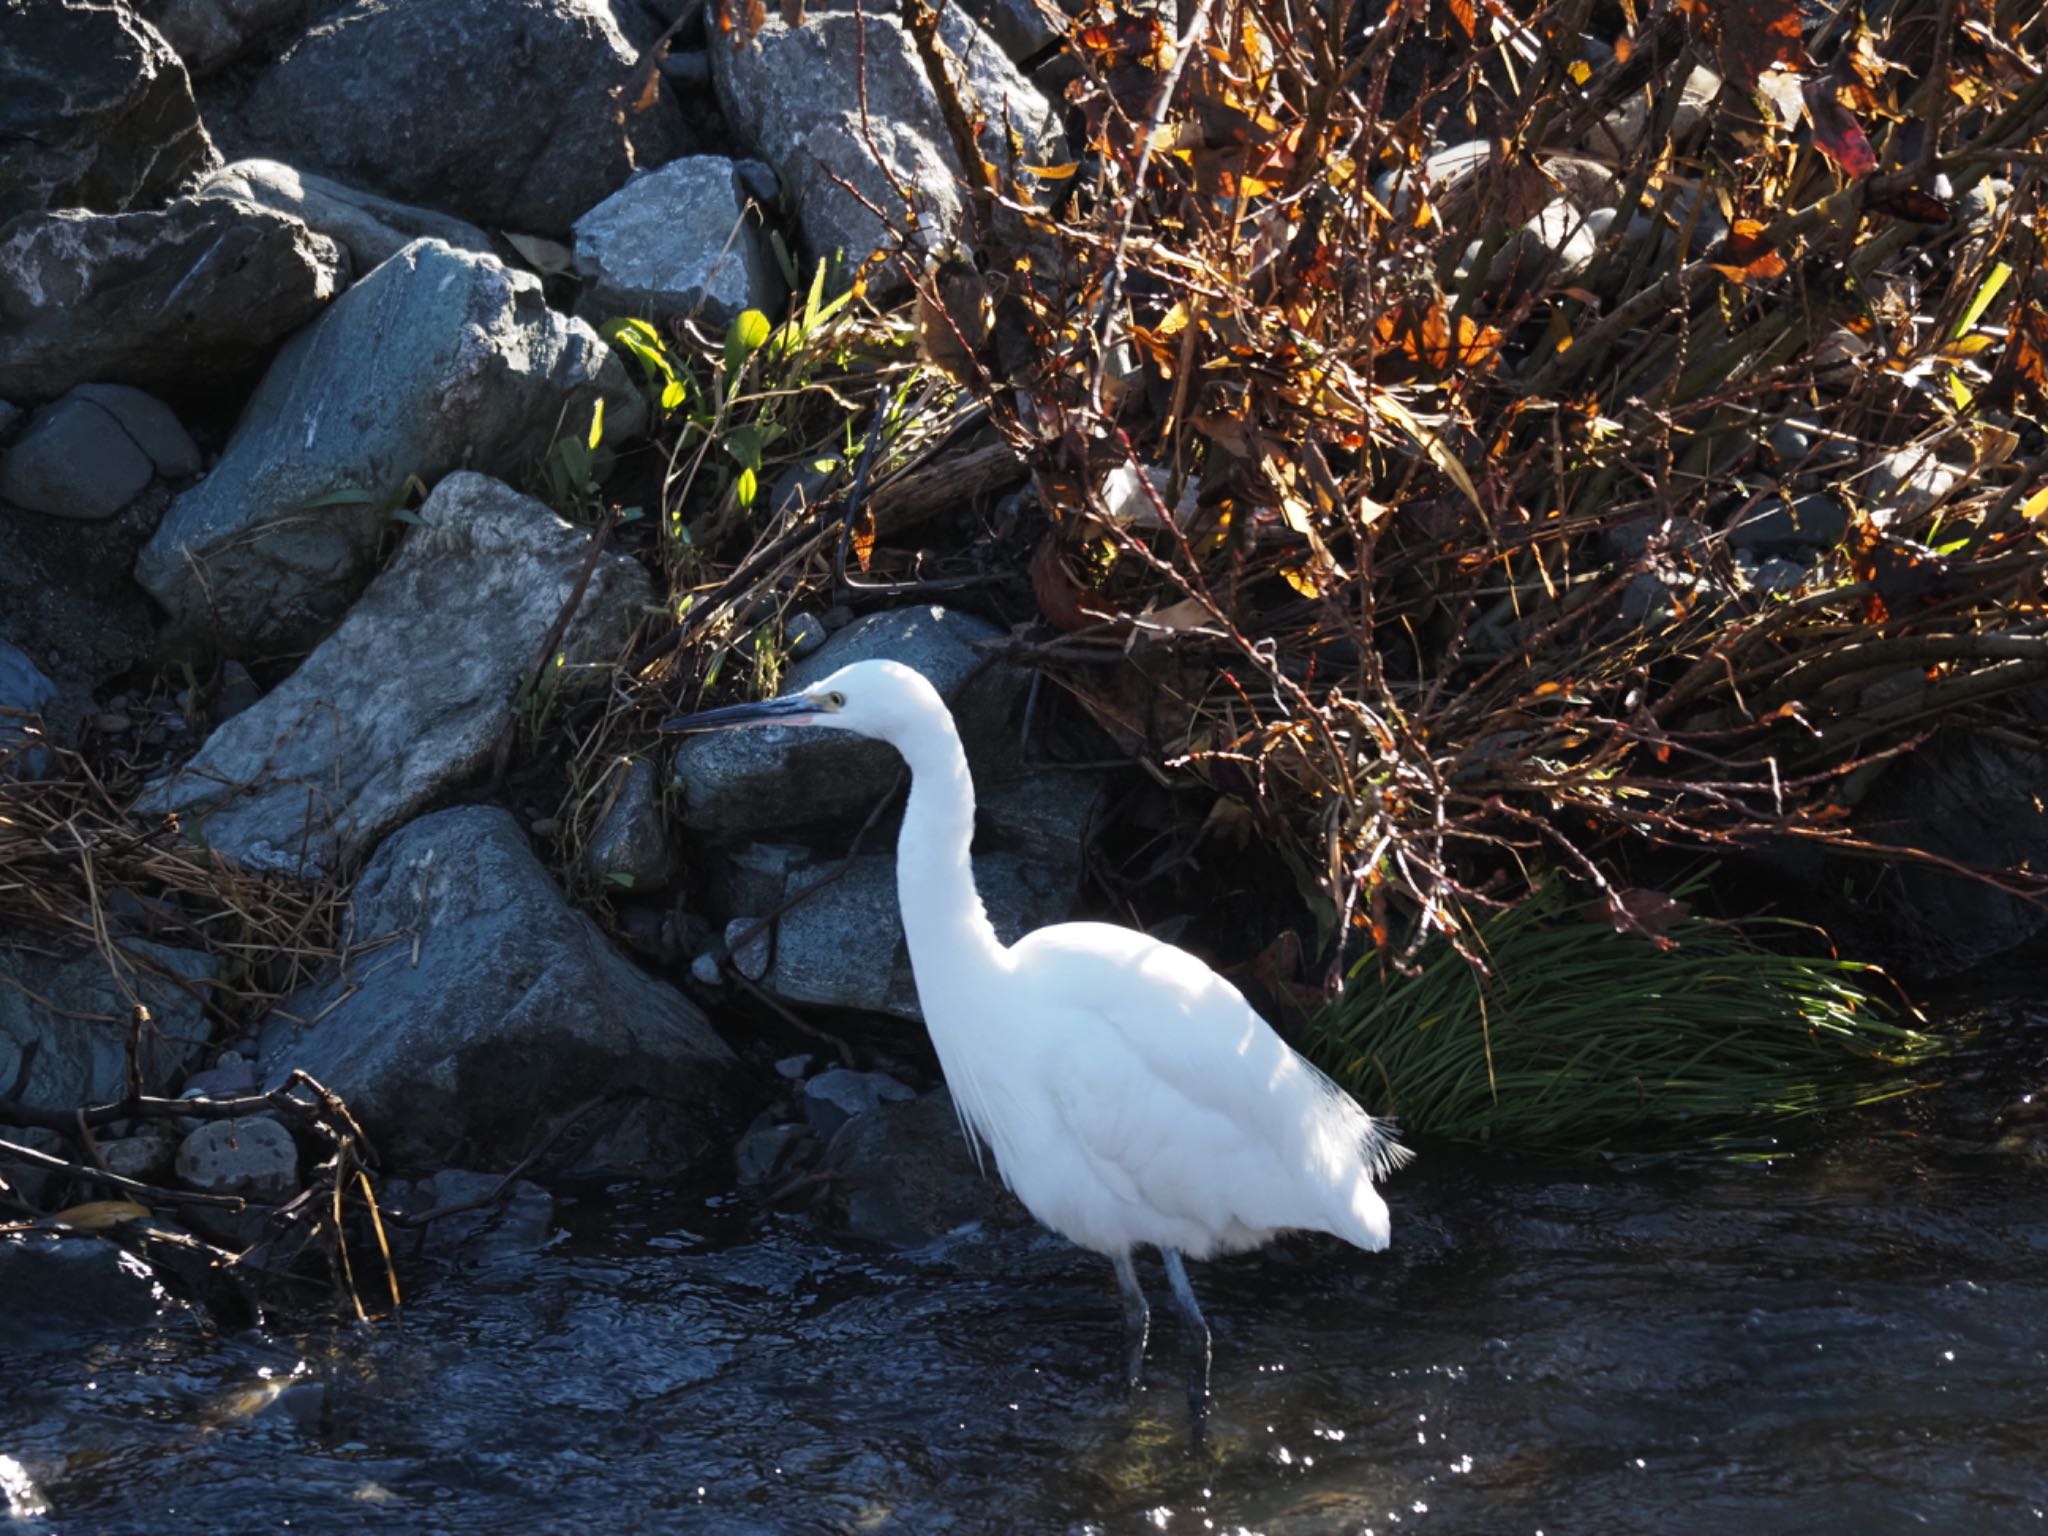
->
xmin=664 ymin=662 xmax=1407 ymax=1444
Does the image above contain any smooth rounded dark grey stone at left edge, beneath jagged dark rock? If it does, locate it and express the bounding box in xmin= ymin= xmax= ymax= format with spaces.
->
xmin=0 ymin=385 xmax=199 ymax=522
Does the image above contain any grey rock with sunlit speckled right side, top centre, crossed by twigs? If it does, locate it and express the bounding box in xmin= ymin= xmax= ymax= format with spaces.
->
xmin=711 ymin=8 xmax=1059 ymax=289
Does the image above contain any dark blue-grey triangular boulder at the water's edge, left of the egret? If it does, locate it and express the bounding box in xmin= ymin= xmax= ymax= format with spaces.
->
xmin=264 ymin=807 xmax=731 ymax=1176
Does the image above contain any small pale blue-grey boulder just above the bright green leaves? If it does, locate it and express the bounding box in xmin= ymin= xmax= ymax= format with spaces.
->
xmin=575 ymin=156 xmax=786 ymax=326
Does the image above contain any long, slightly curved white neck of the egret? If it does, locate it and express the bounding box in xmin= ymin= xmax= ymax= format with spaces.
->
xmin=897 ymin=698 xmax=1006 ymax=999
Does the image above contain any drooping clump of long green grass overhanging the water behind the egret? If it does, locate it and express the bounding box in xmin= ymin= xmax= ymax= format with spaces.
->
xmin=1309 ymin=893 xmax=1944 ymax=1155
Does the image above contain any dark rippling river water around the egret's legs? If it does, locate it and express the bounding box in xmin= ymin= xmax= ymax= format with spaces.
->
xmin=0 ymin=1026 xmax=2048 ymax=1536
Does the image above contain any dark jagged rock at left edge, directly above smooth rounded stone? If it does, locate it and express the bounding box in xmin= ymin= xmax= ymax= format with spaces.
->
xmin=0 ymin=197 xmax=348 ymax=399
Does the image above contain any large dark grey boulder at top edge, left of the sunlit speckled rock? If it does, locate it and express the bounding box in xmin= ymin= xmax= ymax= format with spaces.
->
xmin=219 ymin=0 xmax=690 ymax=236
